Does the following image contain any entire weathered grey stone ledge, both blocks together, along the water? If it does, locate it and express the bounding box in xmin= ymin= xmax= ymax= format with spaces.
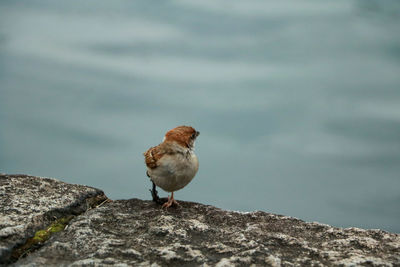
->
xmin=0 ymin=175 xmax=400 ymax=266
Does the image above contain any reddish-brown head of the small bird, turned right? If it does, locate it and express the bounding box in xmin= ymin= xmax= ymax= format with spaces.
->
xmin=164 ymin=126 xmax=200 ymax=149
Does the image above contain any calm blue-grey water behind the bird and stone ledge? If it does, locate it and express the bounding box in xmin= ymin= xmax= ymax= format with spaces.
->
xmin=0 ymin=0 xmax=400 ymax=232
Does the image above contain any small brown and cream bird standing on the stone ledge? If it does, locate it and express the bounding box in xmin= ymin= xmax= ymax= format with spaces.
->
xmin=143 ymin=125 xmax=200 ymax=209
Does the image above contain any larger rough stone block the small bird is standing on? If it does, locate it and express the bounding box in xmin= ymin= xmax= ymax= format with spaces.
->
xmin=14 ymin=199 xmax=400 ymax=266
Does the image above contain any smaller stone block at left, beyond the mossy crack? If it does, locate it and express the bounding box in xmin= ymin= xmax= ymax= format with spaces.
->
xmin=0 ymin=174 xmax=105 ymax=264
